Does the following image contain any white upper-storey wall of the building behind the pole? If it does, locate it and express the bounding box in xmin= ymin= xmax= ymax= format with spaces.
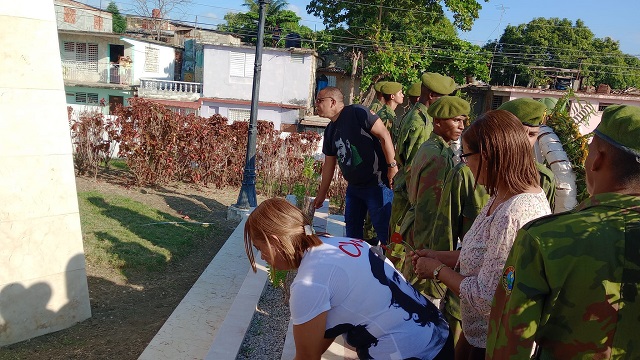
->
xmin=203 ymin=45 xmax=316 ymax=107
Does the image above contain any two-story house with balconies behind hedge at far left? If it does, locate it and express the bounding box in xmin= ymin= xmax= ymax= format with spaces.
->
xmin=54 ymin=0 xmax=186 ymax=113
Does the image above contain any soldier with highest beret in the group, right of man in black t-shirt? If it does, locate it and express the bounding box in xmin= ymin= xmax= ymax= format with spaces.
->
xmin=389 ymin=73 xmax=456 ymax=259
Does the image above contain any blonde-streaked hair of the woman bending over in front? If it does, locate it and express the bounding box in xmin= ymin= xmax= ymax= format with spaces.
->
xmin=244 ymin=198 xmax=322 ymax=272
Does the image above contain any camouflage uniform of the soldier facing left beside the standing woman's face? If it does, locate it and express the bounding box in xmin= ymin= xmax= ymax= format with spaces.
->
xmin=400 ymin=133 xmax=453 ymax=298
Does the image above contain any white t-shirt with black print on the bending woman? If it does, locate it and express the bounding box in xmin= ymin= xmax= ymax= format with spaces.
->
xmin=290 ymin=237 xmax=449 ymax=359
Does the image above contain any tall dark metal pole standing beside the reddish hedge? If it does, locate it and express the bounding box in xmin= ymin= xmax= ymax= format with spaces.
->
xmin=234 ymin=0 xmax=271 ymax=209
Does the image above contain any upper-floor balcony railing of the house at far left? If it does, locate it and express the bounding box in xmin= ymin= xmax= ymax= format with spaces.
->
xmin=62 ymin=60 xmax=133 ymax=85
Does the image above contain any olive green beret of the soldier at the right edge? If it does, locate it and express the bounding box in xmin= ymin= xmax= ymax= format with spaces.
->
xmin=594 ymin=105 xmax=640 ymax=161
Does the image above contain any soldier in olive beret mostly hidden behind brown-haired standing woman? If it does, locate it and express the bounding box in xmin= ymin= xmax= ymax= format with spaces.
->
xmin=498 ymin=98 xmax=556 ymax=211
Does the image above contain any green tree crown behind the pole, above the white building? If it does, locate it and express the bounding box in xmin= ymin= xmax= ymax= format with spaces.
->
xmin=218 ymin=0 xmax=313 ymax=47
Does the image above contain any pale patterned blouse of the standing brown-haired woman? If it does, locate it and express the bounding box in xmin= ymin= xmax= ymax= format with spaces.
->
xmin=458 ymin=190 xmax=551 ymax=348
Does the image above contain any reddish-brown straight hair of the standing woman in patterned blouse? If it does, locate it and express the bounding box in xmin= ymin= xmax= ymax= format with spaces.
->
xmin=462 ymin=110 xmax=540 ymax=195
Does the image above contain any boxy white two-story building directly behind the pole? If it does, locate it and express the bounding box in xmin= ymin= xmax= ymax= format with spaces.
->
xmin=200 ymin=44 xmax=317 ymax=131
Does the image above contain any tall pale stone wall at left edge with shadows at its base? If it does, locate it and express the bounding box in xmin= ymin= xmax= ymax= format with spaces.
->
xmin=0 ymin=0 xmax=91 ymax=346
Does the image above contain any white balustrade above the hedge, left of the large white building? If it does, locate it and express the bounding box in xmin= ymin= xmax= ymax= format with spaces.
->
xmin=138 ymin=78 xmax=202 ymax=101
